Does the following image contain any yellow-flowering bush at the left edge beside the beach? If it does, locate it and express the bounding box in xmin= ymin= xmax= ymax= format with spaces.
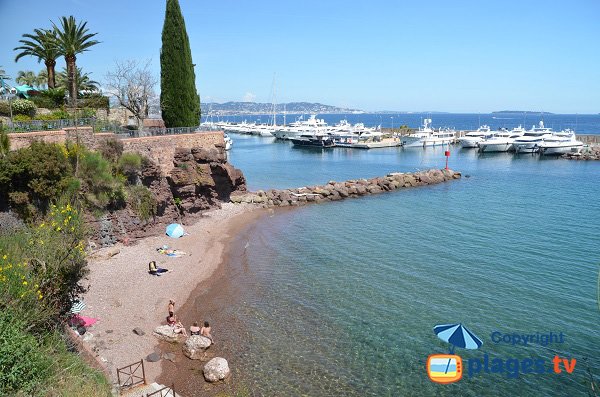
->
xmin=0 ymin=203 xmax=87 ymax=322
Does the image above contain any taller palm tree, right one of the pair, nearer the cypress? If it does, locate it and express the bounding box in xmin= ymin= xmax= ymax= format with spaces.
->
xmin=52 ymin=15 xmax=99 ymax=104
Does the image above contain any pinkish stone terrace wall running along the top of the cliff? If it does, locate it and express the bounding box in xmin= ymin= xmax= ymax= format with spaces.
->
xmin=8 ymin=127 xmax=225 ymax=175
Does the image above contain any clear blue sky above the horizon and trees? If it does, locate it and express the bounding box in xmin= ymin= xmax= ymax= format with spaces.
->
xmin=0 ymin=0 xmax=600 ymax=113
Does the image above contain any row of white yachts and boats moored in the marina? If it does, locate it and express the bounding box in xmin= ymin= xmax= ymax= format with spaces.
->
xmin=213 ymin=115 xmax=583 ymax=155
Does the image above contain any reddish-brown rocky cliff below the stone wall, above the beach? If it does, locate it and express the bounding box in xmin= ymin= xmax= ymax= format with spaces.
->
xmin=86 ymin=145 xmax=246 ymax=247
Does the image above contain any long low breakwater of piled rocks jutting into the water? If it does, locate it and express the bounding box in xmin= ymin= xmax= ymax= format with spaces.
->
xmin=230 ymin=169 xmax=461 ymax=207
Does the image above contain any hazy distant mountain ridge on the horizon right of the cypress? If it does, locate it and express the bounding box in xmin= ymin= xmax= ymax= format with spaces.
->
xmin=202 ymin=102 xmax=364 ymax=115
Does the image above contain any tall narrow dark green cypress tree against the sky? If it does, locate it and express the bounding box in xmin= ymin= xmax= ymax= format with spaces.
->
xmin=160 ymin=0 xmax=200 ymax=128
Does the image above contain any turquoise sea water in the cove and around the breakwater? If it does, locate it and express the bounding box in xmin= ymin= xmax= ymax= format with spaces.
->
xmin=220 ymin=135 xmax=600 ymax=396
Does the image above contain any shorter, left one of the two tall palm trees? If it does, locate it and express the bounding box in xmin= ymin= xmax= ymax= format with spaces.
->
xmin=14 ymin=29 xmax=60 ymax=88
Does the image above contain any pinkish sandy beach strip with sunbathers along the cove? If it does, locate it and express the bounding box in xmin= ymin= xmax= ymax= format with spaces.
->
xmin=82 ymin=204 xmax=266 ymax=382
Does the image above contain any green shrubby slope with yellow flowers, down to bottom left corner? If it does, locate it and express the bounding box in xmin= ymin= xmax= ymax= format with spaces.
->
xmin=0 ymin=209 xmax=110 ymax=397
